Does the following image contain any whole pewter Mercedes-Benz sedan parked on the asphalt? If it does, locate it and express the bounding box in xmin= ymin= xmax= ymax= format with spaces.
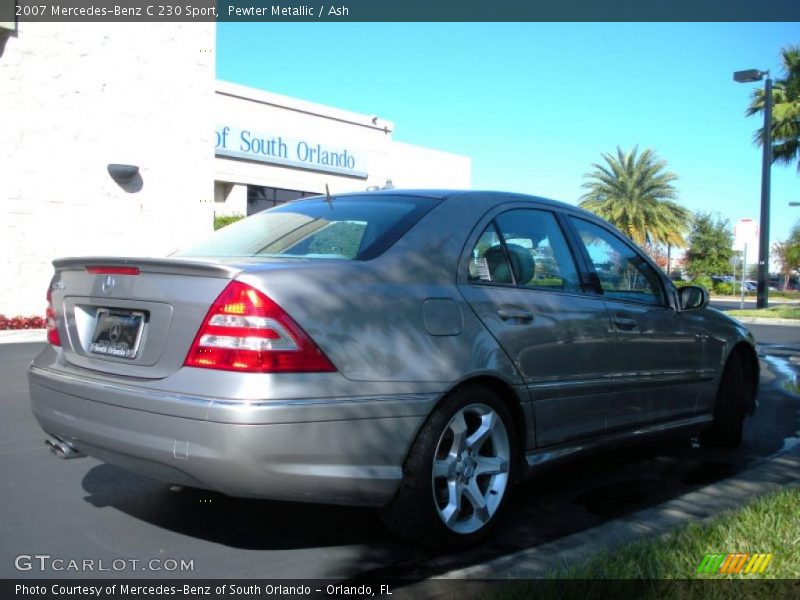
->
xmin=29 ymin=190 xmax=759 ymax=546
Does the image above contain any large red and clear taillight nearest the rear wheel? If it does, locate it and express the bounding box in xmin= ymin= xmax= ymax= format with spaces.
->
xmin=184 ymin=281 xmax=336 ymax=373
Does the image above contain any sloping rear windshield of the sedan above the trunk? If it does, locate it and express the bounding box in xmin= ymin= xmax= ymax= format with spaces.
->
xmin=176 ymin=196 xmax=439 ymax=260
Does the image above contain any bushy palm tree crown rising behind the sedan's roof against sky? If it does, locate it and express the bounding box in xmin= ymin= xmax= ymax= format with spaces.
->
xmin=580 ymin=146 xmax=691 ymax=246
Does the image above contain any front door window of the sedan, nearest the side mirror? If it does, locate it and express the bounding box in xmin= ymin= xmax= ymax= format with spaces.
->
xmin=572 ymin=218 xmax=665 ymax=306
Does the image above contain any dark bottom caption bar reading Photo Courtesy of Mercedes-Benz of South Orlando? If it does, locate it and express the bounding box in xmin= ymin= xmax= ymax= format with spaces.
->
xmin=0 ymin=577 xmax=800 ymax=600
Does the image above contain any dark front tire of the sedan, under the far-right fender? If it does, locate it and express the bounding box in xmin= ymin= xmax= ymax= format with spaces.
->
xmin=701 ymin=352 xmax=747 ymax=448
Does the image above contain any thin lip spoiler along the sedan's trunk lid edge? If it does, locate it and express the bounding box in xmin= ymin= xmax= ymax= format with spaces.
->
xmin=53 ymin=256 xmax=242 ymax=279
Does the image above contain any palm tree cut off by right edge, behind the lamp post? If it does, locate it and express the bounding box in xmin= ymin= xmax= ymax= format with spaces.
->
xmin=746 ymin=45 xmax=800 ymax=171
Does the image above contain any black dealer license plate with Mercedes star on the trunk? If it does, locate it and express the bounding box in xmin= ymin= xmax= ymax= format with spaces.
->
xmin=89 ymin=308 xmax=146 ymax=360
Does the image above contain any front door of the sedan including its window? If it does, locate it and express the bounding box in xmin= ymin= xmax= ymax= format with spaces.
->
xmin=570 ymin=217 xmax=703 ymax=431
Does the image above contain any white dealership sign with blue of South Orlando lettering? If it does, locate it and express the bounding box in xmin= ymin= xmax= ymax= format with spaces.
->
xmin=214 ymin=125 xmax=367 ymax=179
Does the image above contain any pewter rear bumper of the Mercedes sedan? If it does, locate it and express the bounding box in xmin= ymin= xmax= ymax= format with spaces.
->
xmin=29 ymin=366 xmax=437 ymax=506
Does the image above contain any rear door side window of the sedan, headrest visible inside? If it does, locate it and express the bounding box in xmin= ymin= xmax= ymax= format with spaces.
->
xmin=462 ymin=209 xmax=580 ymax=291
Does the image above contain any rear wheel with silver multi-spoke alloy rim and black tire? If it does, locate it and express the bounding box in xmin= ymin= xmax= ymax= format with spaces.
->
xmin=379 ymin=384 xmax=518 ymax=549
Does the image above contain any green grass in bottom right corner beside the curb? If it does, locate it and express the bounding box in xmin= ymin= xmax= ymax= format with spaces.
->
xmin=482 ymin=487 xmax=800 ymax=600
